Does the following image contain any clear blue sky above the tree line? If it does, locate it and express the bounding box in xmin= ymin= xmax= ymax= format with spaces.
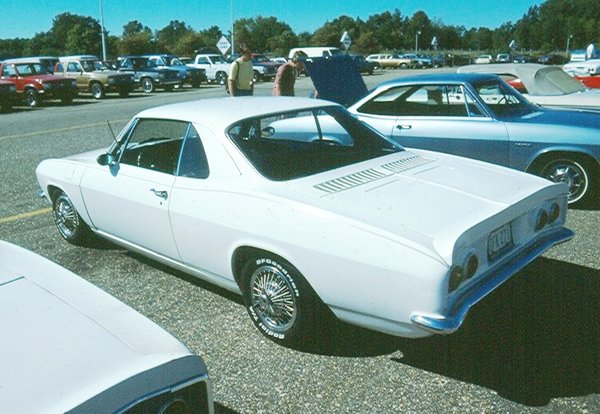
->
xmin=0 ymin=0 xmax=543 ymax=39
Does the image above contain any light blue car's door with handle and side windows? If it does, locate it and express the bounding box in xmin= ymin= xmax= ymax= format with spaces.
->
xmin=360 ymin=84 xmax=509 ymax=165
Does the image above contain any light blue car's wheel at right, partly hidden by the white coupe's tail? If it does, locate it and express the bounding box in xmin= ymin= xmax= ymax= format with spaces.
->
xmin=538 ymin=156 xmax=596 ymax=206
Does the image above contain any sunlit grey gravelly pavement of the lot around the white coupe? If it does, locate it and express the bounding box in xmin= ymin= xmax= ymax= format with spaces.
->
xmin=0 ymin=69 xmax=600 ymax=413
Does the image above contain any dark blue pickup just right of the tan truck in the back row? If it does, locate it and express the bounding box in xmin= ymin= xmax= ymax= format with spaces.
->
xmin=116 ymin=56 xmax=180 ymax=93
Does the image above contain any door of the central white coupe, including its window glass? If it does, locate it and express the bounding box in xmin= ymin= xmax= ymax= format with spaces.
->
xmin=81 ymin=119 xmax=189 ymax=260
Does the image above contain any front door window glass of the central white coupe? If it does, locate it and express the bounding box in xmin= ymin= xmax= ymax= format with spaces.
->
xmin=120 ymin=119 xmax=188 ymax=174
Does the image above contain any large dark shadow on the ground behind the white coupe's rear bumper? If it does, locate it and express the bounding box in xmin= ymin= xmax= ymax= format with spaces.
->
xmin=305 ymin=258 xmax=600 ymax=406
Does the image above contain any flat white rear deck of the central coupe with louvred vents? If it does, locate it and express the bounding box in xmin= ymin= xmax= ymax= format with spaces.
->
xmin=290 ymin=151 xmax=566 ymax=263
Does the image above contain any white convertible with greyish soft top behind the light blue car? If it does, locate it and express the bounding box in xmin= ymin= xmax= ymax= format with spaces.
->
xmin=457 ymin=63 xmax=600 ymax=111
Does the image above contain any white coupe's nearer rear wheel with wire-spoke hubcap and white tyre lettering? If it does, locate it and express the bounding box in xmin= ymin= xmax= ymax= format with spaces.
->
xmin=240 ymin=255 xmax=328 ymax=346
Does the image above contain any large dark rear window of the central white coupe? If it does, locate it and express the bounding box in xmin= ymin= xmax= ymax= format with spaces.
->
xmin=227 ymin=106 xmax=403 ymax=181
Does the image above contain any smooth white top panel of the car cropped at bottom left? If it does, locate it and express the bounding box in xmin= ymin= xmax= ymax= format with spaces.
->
xmin=0 ymin=241 xmax=202 ymax=412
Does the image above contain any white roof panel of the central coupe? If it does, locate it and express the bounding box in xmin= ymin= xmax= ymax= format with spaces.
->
xmin=136 ymin=96 xmax=337 ymax=130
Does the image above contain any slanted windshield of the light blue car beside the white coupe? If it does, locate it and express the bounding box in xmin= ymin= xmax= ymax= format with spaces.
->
xmin=472 ymin=80 xmax=536 ymax=116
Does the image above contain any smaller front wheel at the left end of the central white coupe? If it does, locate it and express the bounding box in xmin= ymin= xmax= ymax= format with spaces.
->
xmin=52 ymin=192 xmax=91 ymax=245
